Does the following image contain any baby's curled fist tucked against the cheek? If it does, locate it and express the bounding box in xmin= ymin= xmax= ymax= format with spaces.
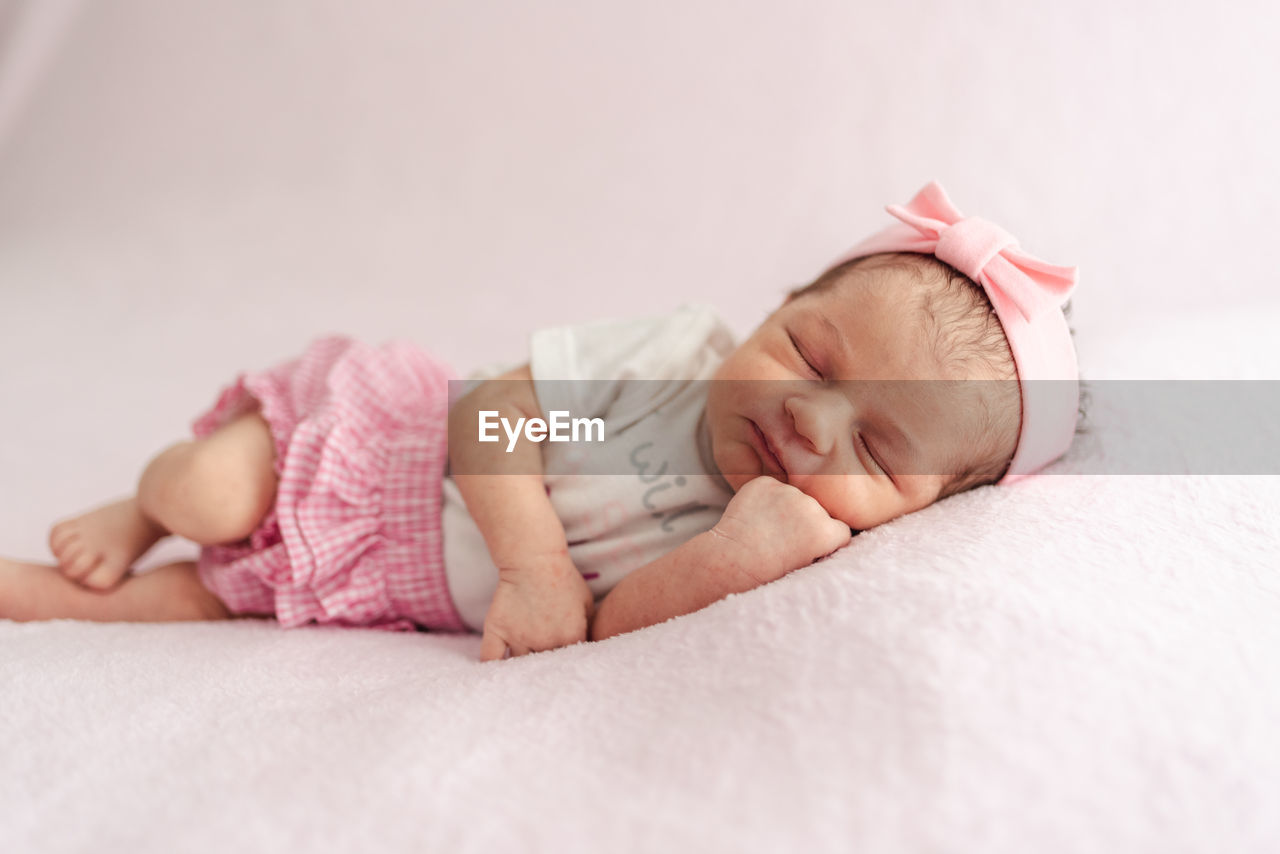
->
xmin=712 ymin=476 xmax=852 ymax=584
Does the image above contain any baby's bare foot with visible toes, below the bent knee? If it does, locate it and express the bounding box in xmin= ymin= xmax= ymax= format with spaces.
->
xmin=49 ymin=498 xmax=168 ymax=590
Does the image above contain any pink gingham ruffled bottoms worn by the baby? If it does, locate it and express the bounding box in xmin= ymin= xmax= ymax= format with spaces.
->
xmin=192 ymin=337 xmax=466 ymax=631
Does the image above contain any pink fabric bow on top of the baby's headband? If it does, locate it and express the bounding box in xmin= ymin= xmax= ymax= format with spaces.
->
xmin=884 ymin=181 xmax=1078 ymax=321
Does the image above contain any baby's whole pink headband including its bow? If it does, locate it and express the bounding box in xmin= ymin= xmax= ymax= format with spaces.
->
xmin=827 ymin=181 xmax=1080 ymax=484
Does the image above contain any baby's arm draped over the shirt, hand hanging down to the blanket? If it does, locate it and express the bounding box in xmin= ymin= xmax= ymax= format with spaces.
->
xmin=449 ymin=365 xmax=594 ymax=661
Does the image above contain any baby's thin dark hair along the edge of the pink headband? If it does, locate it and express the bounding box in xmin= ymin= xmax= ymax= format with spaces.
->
xmin=790 ymin=252 xmax=1088 ymax=501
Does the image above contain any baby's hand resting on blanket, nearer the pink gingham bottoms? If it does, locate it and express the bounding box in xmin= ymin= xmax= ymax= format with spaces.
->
xmin=480 ymin=552 xmax=595 ymax=661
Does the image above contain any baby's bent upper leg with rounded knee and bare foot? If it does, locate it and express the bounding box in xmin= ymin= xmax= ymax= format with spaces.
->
xmin=49 ymin=412 xmax=276 ymax=590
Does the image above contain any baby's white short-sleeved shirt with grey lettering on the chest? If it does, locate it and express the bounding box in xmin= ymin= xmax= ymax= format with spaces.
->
xmin=442 ymin=305 xmax=735 ymax=631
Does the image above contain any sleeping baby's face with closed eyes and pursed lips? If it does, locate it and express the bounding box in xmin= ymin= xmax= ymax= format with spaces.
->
xmin=707 ymin=270 xmax=1018 ymax=530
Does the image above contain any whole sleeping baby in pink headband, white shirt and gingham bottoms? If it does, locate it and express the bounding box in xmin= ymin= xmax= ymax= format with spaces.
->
xmin=0 ymin=182 xmax=1079 ymax=661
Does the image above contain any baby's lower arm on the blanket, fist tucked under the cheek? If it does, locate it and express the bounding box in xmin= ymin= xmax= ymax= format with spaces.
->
xmin=591 ymin=478 xmax=851 ymax=640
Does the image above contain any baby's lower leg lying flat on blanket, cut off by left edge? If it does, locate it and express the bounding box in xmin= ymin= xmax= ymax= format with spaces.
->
xmin=0 ymin=558 xmax=230 ymax=622
